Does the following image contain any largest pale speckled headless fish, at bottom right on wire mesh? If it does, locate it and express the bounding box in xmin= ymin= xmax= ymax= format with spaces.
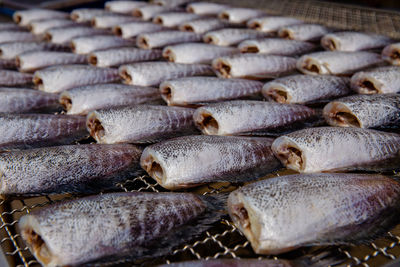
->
xmin=228 ymin=173 xmax=400 ymax=255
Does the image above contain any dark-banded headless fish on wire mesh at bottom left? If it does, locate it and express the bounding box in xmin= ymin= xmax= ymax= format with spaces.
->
xmin=19 ymin=192 xmax=224 ymax=267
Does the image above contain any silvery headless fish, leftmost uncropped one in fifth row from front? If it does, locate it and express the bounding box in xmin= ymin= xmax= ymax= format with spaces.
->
xmin=33 ymin=65 xmax=119 ymax=93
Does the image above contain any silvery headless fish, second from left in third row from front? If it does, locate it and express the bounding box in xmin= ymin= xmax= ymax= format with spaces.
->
xmin=86 ymin=105 xmax=196 ymax=144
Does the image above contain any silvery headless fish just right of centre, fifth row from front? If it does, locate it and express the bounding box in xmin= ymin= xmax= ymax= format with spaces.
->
xmin=212 ymin=54 xmax=296 ymax=79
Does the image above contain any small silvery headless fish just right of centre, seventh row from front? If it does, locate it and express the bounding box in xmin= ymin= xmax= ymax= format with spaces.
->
xmin=203 ymin=28 xmax=271 ymax=46
